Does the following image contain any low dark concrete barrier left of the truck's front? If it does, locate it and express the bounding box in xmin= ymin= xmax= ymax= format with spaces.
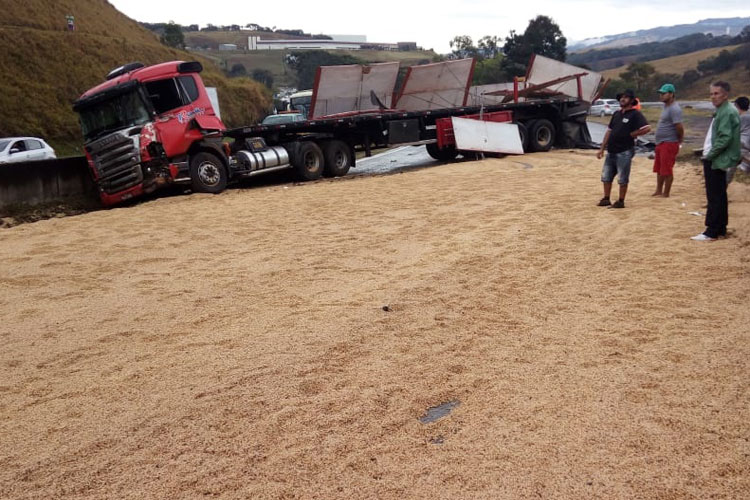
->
xmin=0 ymin=156 xmax=99 ymax=209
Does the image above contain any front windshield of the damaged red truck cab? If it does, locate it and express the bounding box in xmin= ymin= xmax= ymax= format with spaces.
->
xmin=79 ymin=90 xmax=150 ymax=140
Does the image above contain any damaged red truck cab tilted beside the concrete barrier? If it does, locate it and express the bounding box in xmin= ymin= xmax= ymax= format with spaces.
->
xmin=73 ymin=61 xmax=228 ymax=205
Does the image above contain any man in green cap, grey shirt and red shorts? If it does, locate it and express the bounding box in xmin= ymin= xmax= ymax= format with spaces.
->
xmin=652 ymin=83 xmax=685 ymax=198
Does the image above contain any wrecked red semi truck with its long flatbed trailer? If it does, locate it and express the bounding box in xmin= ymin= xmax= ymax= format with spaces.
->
xmin=73 ymin=61 xmax=590 ymax=205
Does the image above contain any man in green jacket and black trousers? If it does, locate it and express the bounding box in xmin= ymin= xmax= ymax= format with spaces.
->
xmin=691 ymin=81 xmax=740 ymax=241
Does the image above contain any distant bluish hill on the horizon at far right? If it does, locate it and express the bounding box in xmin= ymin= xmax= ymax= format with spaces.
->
xmin=568 ymin=17 xmax=750 ymax=52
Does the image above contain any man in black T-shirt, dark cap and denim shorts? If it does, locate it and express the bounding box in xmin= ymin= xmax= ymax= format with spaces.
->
xmin=596 ymin=89 xmax=651 ymax=208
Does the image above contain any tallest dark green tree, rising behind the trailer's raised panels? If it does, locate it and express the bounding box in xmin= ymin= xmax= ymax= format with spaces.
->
xmin=503 ymin=16 xmax=568 ymax=76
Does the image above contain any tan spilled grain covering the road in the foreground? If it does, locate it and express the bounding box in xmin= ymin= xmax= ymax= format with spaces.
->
xmin=0 ymin=151 xmax=750 ymax=498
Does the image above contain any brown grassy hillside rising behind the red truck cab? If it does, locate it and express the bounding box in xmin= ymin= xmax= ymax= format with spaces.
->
xmin=0 ymin=0 xmax=270 ymax=154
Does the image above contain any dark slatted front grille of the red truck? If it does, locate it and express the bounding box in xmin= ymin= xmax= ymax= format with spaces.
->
xmin=88 ymin=133 xmax=143 ymax=194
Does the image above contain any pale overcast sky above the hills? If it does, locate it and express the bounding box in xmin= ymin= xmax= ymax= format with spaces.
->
xmin=109 ymin=0 xmax=750 ymax=53
